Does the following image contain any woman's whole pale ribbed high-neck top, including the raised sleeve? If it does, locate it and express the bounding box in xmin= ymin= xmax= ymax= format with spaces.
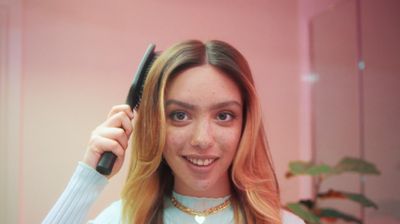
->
xmin=42 ymin=163 xmax=304 ymax=224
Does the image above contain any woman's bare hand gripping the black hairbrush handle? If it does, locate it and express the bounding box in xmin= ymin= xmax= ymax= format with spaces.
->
xmin=83 ymin=104 xmax=135 ymax=178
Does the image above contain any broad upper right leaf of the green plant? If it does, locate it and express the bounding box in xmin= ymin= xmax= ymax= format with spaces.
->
xmin=333 ymin=157 xmax=381 ymax=175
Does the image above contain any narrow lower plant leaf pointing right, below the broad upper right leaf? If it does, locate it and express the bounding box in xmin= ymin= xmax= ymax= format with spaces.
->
xmin=317 ymin=189 xmax=378 ymax=209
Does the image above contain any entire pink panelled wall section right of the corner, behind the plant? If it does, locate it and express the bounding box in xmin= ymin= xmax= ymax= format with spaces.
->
xmin=299 ymin=0 xmax=400 ymax=224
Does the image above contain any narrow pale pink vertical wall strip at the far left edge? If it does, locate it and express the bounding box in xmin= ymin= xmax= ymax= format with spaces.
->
xmin=0 ymin=0 xmax=22 ymax=223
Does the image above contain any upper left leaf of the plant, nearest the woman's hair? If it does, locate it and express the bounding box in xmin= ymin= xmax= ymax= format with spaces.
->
xmin=286 ymin=161 xmax=332 ymax=178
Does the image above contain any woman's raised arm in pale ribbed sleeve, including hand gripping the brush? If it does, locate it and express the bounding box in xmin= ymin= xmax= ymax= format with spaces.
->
xmin=43 ymin=105 xmax=134 ymax=224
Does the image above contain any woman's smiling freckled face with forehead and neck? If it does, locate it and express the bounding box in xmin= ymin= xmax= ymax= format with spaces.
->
xmin=163 ymin=65 xmax=243 ymax=197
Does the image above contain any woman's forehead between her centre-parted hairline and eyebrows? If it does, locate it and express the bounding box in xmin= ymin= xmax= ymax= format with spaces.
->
xmin=165 ymin=64 xmax=242 ymax=103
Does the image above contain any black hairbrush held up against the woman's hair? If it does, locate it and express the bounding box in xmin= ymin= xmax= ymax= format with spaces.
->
xmin=96 ymin=44 xmax=157 ymax=175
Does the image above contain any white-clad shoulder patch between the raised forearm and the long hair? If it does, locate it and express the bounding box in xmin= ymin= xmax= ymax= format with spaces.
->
xmin=89 ymin=200 xmax=122 ymax=224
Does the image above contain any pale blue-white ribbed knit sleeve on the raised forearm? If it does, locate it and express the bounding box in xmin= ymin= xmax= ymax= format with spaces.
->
xmin=42 ymin=162 xmax=108 ymax=224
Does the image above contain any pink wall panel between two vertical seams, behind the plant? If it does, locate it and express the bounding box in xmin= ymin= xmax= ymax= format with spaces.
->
xmin=310 ymin=0 xmax=361 ymax=217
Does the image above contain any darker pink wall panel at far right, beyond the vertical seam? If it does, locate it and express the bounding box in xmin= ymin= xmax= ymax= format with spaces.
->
xmin=361 ymin=0 xmax=400 ymax=224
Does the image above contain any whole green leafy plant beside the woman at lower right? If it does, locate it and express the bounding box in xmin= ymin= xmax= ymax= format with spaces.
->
xmin=286 ymin=157 xmax=380 ymax=224
